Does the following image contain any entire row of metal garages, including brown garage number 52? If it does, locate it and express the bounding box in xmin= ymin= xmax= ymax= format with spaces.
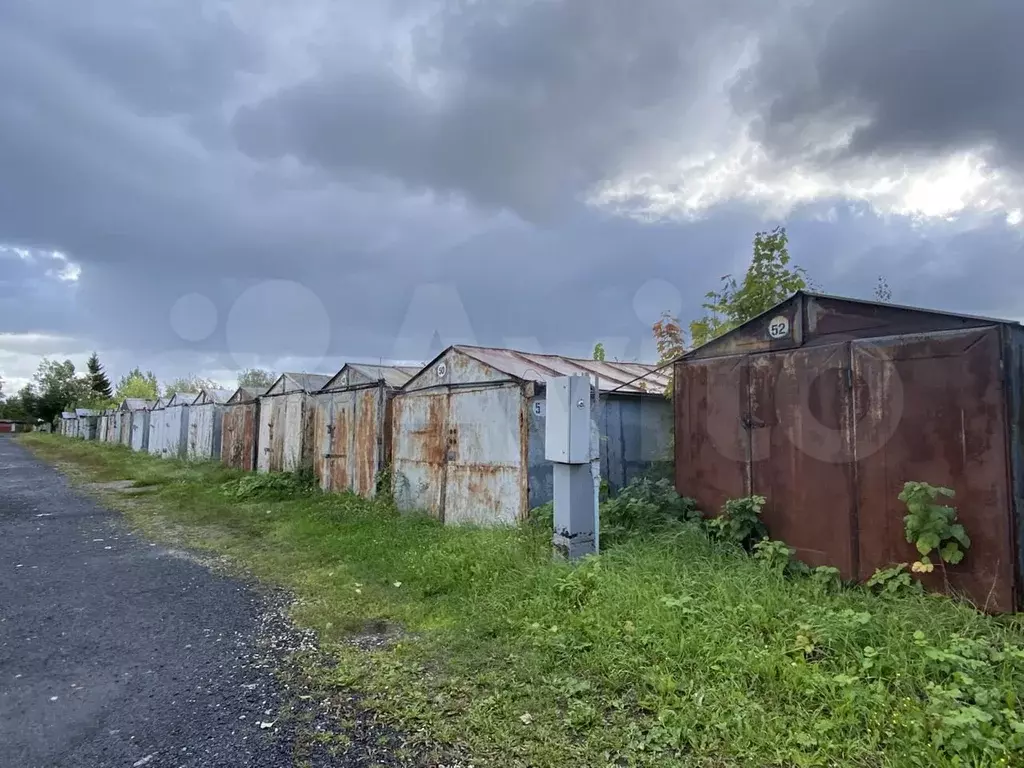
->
xmin=51 ymin=291 xmax=1024 ymax=611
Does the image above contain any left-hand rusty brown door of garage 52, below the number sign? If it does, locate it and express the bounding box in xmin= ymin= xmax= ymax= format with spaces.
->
xmin=676 ymin=344 xmax=856 ymax=579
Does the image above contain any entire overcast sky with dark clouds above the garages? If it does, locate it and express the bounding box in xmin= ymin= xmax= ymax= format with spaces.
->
xmin=0 ymin=0 xmax=1024 ymax=391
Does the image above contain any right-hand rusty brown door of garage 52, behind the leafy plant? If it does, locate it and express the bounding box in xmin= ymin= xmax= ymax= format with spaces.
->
xmin=853 ymin=328 xmax=1016 ymax=611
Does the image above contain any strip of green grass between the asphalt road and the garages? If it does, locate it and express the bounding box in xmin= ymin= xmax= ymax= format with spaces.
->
xmin=23 ymin=435 xmax=1024 ymax=767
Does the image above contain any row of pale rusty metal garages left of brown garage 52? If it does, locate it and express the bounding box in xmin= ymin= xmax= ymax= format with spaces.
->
xmin=59 ymin=345 xmax=673 ymax=523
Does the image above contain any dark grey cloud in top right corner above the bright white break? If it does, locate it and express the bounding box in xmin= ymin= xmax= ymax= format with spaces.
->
xmin=735 ymin=0 xmax=1024 ymax=171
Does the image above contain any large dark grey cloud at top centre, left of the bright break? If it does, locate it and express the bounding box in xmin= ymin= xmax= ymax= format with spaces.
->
xmin=236 ymin=0 xmax=759 ymax=222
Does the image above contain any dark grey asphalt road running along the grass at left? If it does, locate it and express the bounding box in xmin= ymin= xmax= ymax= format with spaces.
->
xmin=0 ymin=436 xmax=362 ymax=768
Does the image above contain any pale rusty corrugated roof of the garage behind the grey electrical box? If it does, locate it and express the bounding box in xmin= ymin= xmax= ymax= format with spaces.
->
xmin=454 ymin=344 xmax=671 ymax=394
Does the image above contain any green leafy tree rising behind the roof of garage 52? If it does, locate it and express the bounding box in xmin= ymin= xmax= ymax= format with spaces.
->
xmin=690 ymin=226 xmax=808 ymax=346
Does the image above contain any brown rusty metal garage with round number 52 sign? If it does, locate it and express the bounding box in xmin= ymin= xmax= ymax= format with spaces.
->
xmin=674 ymin=292 xmax=1024 ymax=611
